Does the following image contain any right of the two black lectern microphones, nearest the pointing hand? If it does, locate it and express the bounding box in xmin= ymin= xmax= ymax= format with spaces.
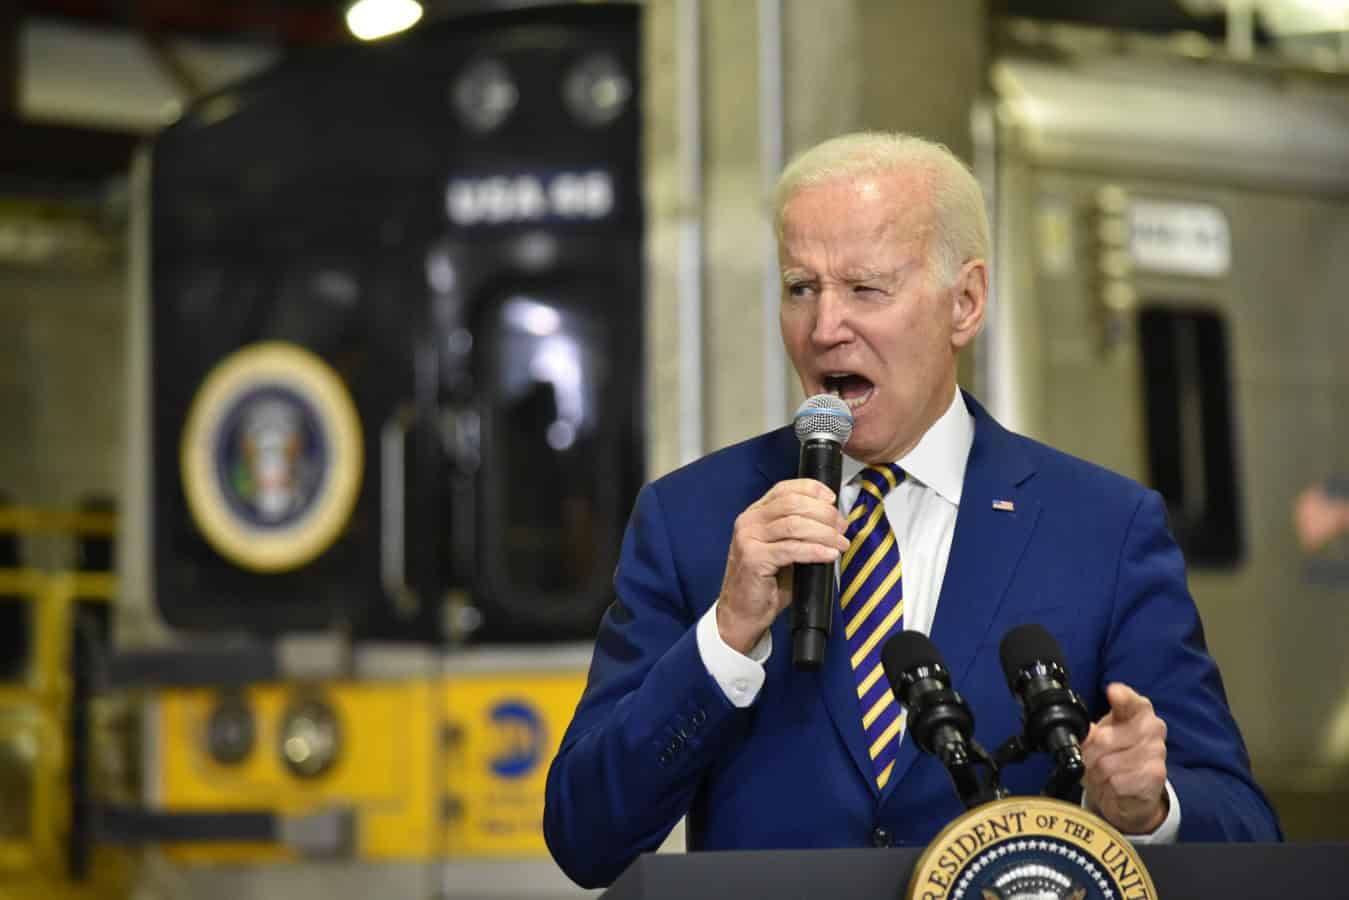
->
xmin=998 ymin=625 xmax=1091 ymax=800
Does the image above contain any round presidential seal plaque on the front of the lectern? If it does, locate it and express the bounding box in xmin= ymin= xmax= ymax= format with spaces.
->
xmin=905 ymin=797 xmax=1157 ymax=900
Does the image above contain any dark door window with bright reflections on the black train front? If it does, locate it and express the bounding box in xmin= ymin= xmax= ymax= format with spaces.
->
xmin=479 ymin=291 xmax=626 ymax=634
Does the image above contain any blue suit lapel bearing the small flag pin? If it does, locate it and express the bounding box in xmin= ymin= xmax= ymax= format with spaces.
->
xmin=879 ymin=394 xmax=1040 ymax=799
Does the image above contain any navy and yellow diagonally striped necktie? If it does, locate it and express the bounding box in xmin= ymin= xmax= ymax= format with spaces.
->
xmin=839 ymin=463 xmax=904 ymax=789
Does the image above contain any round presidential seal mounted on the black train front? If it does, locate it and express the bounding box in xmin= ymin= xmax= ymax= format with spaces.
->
xmin=181 ymin=341 xmax=363 ymax=572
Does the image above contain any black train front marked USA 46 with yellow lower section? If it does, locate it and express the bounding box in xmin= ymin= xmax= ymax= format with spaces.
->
xmin=109 ymin=5 xmax=643 ymax=877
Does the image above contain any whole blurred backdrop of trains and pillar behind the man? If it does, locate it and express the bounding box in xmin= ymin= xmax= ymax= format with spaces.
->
xmin=0 ymin=0 xmax=1349 ymax=900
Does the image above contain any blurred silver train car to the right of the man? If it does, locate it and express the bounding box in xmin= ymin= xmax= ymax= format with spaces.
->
xmin=975 ymin=23 xmax=1349 ymax=838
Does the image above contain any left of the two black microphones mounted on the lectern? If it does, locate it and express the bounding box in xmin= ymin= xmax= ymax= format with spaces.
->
xmin=881 ymin=631 xmax=1006 ymax=810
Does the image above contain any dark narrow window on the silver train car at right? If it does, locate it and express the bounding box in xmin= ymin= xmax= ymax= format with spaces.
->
xmin=1139 ymin=305 xmax=1242 ymax=568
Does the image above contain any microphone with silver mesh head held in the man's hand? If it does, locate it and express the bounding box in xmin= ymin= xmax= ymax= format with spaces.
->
xmin=792 ymin=394 xmax=853 ymax=672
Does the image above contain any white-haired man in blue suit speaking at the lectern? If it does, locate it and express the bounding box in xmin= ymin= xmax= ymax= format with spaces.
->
xmin=544 ymin=134 xmax=1280 ymax=885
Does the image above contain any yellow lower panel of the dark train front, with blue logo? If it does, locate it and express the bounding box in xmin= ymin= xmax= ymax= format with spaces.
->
xmin=152 ymin=668 xmax=585 ymax=864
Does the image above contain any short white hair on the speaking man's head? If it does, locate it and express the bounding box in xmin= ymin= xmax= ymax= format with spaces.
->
xmin=774 ymin=131 xmax=989 ymax=283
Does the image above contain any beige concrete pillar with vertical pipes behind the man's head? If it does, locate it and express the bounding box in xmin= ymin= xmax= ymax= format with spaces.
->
xmin=643 ymin=0 xmax=987 ymax=478
